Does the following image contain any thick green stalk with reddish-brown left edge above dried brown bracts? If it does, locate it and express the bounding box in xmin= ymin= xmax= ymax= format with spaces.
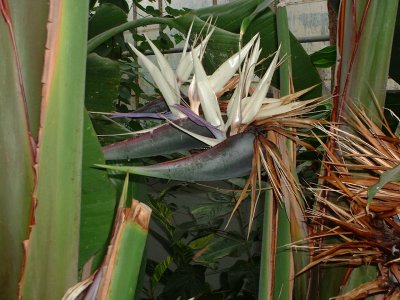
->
xmin=333 ymin=0 xmax=398 ymax=122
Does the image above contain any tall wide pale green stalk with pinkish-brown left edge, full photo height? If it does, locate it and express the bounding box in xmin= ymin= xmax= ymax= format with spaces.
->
xmin=21 ymin=1 xmax=89 ymax=299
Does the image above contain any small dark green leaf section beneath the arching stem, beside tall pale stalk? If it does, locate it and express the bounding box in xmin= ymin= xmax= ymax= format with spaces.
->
xmin=85 ymin=53 xmax=120 ymax=112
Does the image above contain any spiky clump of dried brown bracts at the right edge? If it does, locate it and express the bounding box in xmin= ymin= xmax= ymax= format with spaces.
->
xmin=300 ymin=108 xmax=400 ymax=299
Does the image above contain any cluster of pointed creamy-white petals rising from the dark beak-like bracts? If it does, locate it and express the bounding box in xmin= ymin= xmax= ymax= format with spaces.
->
xmin=131 ymin=25 xmax=307 ymax=146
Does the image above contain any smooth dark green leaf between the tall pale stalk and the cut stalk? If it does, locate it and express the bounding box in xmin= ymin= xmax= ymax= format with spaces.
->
xmin=79 ymin=112 xmax=116 ymax=269
